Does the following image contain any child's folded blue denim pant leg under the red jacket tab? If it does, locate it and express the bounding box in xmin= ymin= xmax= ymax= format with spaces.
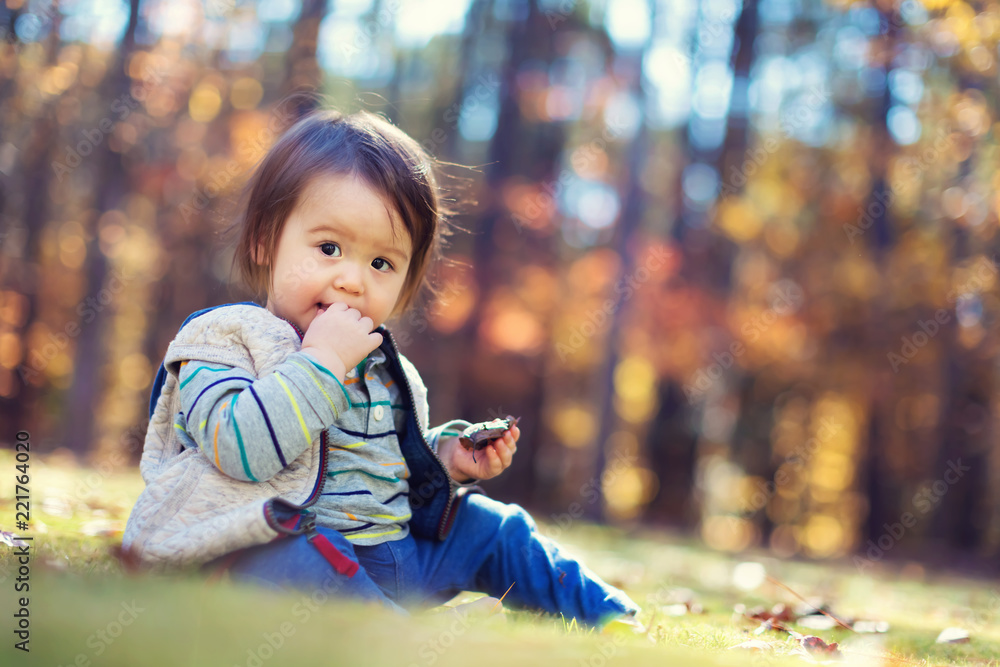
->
xmin=222 ymin=526 xmax=406 ymax=614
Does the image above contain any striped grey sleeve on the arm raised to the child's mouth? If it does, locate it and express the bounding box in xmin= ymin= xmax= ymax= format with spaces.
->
xmin=179 ymin=352 xmax=350 ymax=482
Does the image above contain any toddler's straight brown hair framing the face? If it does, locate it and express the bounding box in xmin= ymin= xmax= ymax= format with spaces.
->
xmin=229 ymin=109 xmax=450 ymax=313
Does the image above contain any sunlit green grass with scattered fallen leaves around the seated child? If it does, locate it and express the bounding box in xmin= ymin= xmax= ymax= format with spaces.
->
xmin=0 ymin=450 xmax=1000 ymax=667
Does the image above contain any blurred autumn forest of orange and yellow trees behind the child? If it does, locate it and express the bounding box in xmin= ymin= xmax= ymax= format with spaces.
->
xmin=0 ymin=0 xmax=1000 ymax=572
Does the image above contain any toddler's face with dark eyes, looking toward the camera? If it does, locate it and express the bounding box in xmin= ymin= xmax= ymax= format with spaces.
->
xmin=267 ymin=174 xmax=411 ymax=332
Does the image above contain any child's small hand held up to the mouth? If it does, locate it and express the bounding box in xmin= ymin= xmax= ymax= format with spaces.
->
xmin=302 ymin=303 xmax=382 ymax=380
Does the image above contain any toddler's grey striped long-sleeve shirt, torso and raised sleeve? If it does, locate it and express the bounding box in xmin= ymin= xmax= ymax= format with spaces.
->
xmin=174 ymin=350 xmax=410 ymax=544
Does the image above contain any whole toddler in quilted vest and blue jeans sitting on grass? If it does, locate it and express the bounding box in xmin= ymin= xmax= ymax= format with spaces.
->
xmin=123 ymin=111 xmax=638 ymax=626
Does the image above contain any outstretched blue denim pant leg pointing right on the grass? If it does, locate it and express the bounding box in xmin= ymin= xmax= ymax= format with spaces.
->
xmin=391 ymin=493 xmax=639 ymax=626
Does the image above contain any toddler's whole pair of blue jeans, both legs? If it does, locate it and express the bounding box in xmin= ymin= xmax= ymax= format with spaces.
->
xmin=219 ymin=493 xmax=639 ymax=626
